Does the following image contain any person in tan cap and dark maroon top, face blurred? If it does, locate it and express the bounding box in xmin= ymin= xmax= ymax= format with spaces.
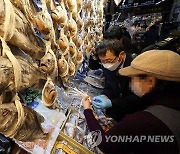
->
xmin=83 ymin=50 xmax=180 ymax=154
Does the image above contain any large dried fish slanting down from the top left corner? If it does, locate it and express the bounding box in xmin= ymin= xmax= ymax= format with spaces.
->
xmin=0 ymin=0 xmax=45 ymax=58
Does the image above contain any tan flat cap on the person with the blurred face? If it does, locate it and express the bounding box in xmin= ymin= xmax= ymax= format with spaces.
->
xmin=119 ymin=50 xmax=180 ymax=81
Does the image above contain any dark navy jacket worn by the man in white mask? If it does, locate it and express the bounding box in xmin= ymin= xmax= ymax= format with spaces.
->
xmin=89 ymin=54 xmax=139 ymax=121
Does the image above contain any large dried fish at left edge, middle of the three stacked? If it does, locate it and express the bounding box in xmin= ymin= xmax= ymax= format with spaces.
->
xmin=0 ymin=56 xmax=46 ymax=97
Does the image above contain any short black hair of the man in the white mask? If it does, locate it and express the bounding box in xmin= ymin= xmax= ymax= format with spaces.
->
xmin=96 ymin=39 xmax=124 ymax=56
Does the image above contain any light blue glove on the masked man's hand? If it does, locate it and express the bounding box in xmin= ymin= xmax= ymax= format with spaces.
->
xmin=91 ymin=95 xmax=112 ymax=109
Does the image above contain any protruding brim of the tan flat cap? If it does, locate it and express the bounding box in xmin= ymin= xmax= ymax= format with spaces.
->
xmin=119 ymin=66 xmax=147 ymax=76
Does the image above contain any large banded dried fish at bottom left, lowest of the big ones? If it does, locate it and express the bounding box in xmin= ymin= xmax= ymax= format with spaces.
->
xmin=0 ymin=98 xmax=47 ymax=142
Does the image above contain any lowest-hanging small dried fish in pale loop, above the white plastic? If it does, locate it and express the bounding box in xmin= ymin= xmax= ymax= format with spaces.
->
xmin=42 ymin=78 xmax=57 ymax=106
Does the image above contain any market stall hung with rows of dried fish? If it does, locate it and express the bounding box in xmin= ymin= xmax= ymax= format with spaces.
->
xmin=0 ymin=0 xmax=113 ymax=153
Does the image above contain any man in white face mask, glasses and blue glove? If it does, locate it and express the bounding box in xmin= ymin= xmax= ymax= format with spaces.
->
xmin=89 ymin=40 xmax=139 ymax=121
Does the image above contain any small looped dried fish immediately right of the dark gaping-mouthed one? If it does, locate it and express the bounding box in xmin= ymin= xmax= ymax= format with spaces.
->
xmin=58 ymin=55 xmax=69 ymax=77
